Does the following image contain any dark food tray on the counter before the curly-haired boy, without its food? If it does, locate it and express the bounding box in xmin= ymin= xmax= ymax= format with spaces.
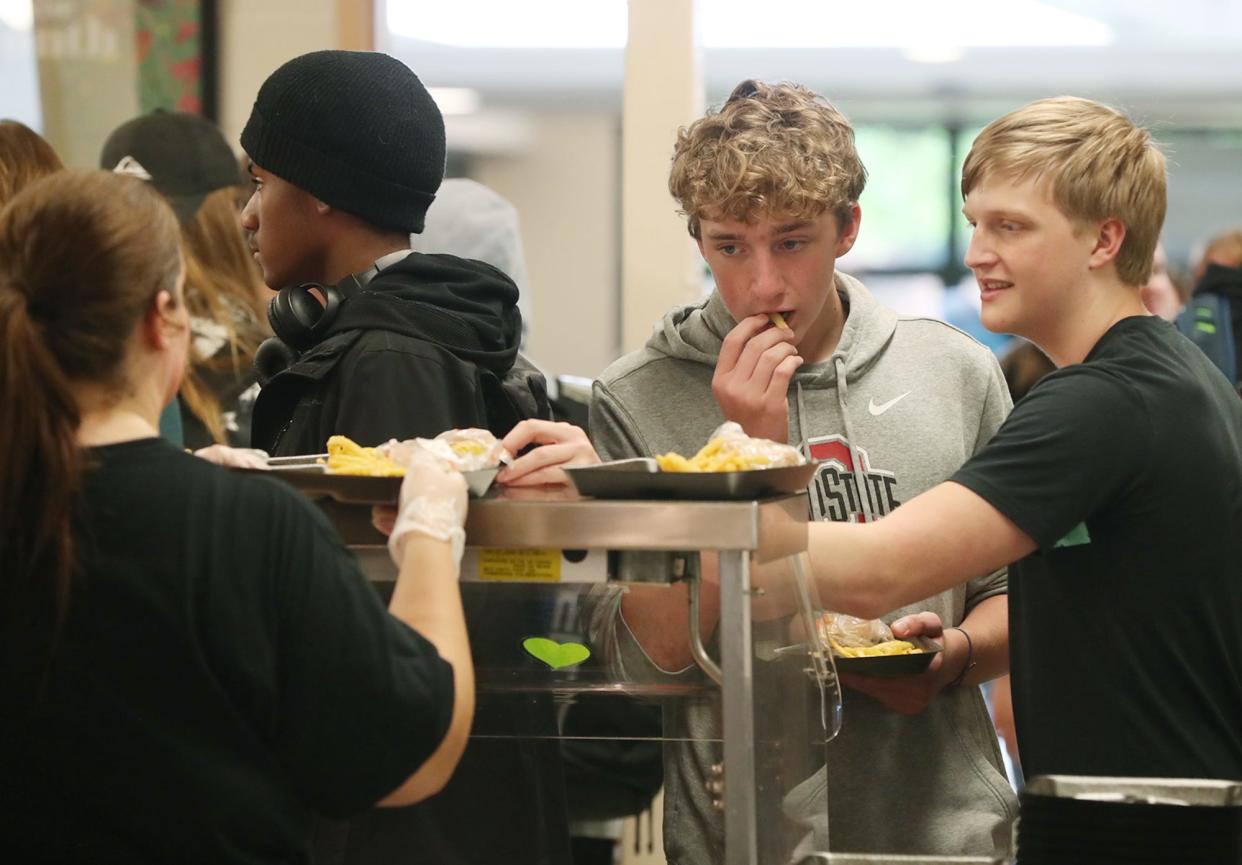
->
xmin=565 ymin=457 xmax=820 ymax=501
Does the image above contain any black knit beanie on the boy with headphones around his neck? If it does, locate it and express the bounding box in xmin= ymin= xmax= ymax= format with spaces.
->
xmin=241 ymin=51 xmax=445 ymax=232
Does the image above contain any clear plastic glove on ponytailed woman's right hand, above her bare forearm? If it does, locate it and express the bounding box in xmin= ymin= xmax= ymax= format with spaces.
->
xmin=389 ymin=447 xmax=466 ymax=570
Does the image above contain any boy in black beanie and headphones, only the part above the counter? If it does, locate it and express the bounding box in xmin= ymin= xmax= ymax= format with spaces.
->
xmin=241 ymin=51 xmax=549 ymax=455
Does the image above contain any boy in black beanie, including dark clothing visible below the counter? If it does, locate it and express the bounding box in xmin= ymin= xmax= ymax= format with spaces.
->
xmin=233 ymin=51 xmax=570 ymax=865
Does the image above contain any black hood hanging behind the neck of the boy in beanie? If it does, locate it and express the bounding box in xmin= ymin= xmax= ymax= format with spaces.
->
xmin=325 ymin=252 xmax=522 ymax=374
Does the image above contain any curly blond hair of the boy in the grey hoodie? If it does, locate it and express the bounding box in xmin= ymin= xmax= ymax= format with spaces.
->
xmin=668 ymin=81 xmax=867 ymax=237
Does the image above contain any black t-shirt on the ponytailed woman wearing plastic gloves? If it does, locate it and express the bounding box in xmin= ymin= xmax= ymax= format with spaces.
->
xmin=0 ymin=439 xmax=453 ymax=865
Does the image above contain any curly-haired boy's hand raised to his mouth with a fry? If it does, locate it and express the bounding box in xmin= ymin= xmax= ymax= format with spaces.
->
xmin=712 ymin=314 xmax=802 ymax=441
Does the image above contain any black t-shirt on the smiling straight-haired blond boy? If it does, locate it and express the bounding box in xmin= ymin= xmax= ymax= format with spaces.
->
xmin=953 ymin=317 xmax=1242 ymax=779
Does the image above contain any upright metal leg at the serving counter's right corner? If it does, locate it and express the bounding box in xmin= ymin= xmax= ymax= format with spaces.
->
xmin=719 ymin=551 xmax=759 ymax=865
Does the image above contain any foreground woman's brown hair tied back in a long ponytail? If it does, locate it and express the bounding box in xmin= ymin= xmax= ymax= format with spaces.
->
xmin=0 ymin=172 xmax=180 ymax=661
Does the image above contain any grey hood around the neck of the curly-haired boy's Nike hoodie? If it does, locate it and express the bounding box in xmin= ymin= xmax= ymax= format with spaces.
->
xmin=647 ymin=272 xmax=897 ymax=388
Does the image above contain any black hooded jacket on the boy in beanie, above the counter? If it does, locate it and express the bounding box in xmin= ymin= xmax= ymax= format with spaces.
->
xmin=251 ymin=252 xmax=550 ymax=456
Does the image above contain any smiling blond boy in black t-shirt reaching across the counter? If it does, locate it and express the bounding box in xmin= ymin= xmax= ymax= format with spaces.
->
xmin=810 ymin=97 xmax=1242 ymax=779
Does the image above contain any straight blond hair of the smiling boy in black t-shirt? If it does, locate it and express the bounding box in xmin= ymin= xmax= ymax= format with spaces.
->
xmin=961 ymin=96 xmax=1167 ymax=286
